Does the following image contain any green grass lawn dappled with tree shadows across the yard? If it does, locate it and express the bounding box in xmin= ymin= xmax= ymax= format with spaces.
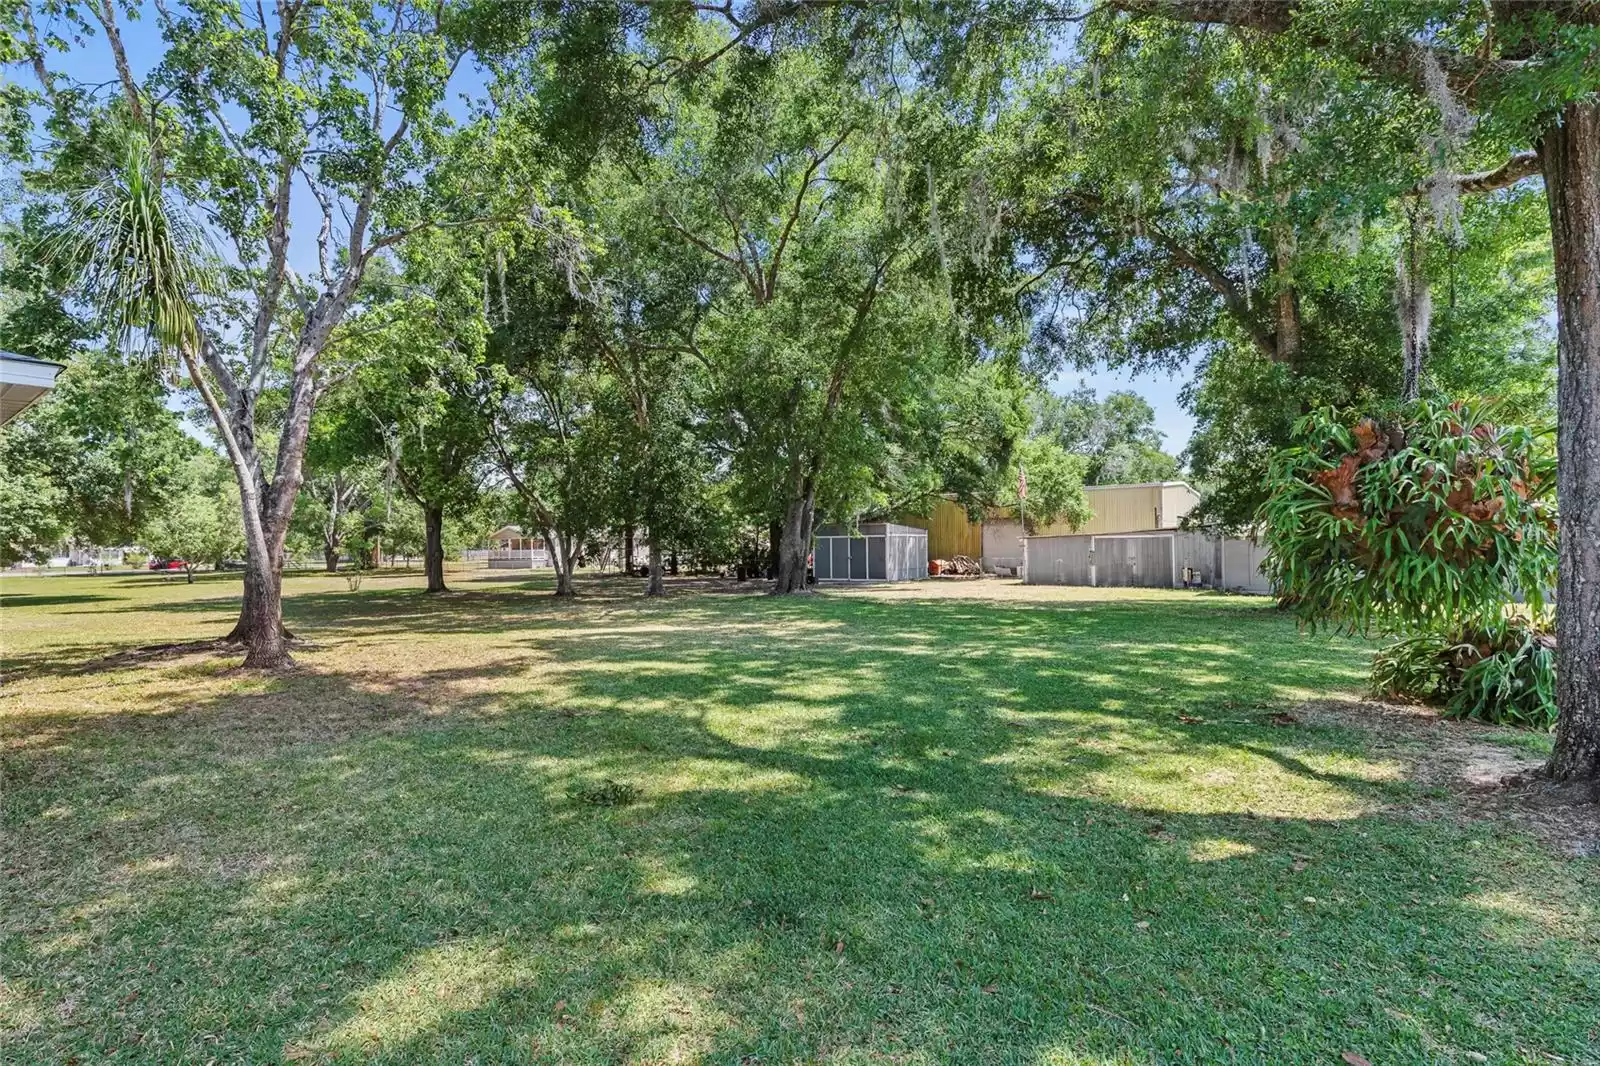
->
xmin=0 ymin=573 xmax=1600 ymax=1066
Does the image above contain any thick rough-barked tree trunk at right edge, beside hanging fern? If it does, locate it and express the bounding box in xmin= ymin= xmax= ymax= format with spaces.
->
xmin=1539 ymin=102 xmax=1600 ymax=781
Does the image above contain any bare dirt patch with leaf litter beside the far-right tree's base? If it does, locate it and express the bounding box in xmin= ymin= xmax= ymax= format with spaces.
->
xmin=1294 ymin=699 xmax=1600 ymax=856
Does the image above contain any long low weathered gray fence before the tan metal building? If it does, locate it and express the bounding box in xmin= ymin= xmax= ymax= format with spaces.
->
xmin=1022 ymin=530 xmax=1272 ymax=595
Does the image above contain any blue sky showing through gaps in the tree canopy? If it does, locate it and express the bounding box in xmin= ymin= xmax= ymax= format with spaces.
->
xmin=13 ymin=3 xmax=1194 ymax=455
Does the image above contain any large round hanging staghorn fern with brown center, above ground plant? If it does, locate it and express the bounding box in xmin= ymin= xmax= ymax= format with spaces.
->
xmin=1261 ymin=402 xmax=1555 ymax=634
